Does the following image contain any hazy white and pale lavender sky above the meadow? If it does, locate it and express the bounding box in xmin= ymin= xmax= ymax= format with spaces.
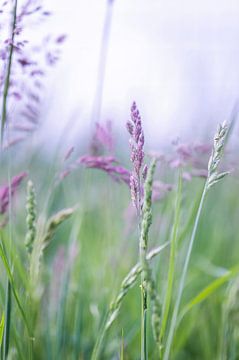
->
xmin=36 ymin=0 xmax=239 ymax=145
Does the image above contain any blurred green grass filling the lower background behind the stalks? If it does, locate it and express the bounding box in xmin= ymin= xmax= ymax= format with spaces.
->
xmin=0 ymin=126 xmax=238 ymax=359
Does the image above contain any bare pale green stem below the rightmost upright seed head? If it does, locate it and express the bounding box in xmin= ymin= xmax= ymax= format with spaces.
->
xmin=163 ymin=182 xmax=207 ymax=360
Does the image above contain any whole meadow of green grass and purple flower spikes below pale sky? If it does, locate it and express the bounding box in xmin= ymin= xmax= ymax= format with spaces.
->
xmin=0 ymin=1 xmax=239 ymax=360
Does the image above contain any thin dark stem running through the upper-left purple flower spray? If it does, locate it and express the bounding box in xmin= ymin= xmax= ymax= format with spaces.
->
xmin=1 ymin=0 xmax=17 ymax=143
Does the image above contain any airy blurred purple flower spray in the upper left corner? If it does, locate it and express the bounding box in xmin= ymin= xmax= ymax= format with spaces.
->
xmin=0 ymin=0 xmax=66 ymax=143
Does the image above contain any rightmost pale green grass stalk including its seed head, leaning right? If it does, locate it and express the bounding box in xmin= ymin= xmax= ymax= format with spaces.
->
xmin=163 ymin=123 xmax=228 ymax=360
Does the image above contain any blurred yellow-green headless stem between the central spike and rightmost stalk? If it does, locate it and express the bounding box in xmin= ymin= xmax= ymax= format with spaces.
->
xmin=160 ymin=172 xmax=182 ymax=354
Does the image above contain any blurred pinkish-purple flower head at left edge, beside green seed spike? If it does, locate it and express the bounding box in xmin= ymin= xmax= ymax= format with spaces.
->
xmin=0 ymin=172 xmax=27 ymax=215
